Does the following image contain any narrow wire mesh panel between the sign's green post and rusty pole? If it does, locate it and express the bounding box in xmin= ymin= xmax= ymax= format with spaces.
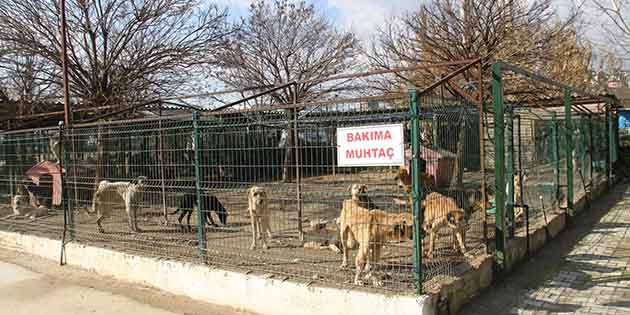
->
xmin=420 ymin=96 xmax=490 ymax=292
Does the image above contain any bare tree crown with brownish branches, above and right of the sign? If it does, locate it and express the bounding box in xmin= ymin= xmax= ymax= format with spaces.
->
xmin=370 ymin=0 xmax=590 ymax=89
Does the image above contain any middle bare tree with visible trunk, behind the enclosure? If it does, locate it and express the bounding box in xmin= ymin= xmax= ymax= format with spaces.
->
xmin=216 ymin=0 xmax=360 ymax=181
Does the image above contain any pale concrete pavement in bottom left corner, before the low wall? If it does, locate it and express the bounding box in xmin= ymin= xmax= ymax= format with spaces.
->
xmin=0 ymin=248 xmax=252 ymax=315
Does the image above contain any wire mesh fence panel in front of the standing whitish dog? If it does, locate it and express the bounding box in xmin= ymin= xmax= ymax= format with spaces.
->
xmin=63 ymin=116 xmax=204 ymax=259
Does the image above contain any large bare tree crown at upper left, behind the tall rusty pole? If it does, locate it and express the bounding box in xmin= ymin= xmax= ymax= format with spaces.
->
xmin=0 ymin=0 xmax=233 ymax=113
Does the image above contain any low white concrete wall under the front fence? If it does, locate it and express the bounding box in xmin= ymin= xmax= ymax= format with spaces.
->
xmin=0 ymin=231 xmax=435 ymax=315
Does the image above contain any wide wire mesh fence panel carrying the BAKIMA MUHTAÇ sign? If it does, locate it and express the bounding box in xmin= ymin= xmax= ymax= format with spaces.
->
xmin=191 ymin=97 xmax=420 ymax=291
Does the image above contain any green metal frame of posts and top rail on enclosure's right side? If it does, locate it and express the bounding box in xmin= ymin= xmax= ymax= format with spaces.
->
xmin=492 ymin=61 xmax=616 ymax=270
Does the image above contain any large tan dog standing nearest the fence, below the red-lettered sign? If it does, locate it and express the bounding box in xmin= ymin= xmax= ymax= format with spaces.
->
xmin=337 ymin=200 xmax=413 ymax=285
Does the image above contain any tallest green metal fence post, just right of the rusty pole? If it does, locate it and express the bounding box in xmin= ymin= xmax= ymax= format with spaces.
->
xmin=492 ymin=63 xmax=506 ymax=267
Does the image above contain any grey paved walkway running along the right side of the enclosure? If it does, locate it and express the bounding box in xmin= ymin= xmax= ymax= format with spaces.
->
xmin=463 ymin=185 xmax=630 ymax=315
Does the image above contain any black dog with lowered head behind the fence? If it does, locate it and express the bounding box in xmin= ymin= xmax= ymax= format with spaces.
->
xmin=171 ymin=194 xmax=227 ymax=231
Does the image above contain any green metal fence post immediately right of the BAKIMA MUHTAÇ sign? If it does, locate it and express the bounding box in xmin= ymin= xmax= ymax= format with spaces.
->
xmin=409 ymin=89 xmax=424 ymax=294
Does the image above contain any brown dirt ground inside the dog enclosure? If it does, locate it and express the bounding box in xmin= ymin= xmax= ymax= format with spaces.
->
xmin=0 ymin=173 xmax=494 ymax=292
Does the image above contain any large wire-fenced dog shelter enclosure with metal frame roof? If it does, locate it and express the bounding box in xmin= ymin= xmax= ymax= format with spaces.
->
xmin=0 ymin=60 xmax=616 ymax=302
